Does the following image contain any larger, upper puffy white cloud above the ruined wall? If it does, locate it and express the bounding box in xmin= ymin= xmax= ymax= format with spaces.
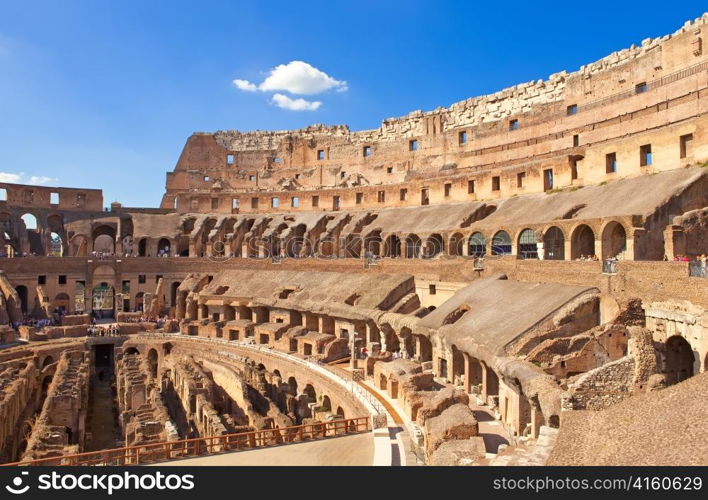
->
xmin=234 ymin=61 xmax=347 ymax=97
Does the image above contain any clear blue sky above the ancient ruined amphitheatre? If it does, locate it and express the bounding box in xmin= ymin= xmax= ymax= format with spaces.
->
xmin=0 ymin=0 xmax=705 ymax=206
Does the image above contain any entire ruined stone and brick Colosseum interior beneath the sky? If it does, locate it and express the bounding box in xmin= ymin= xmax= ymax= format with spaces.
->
xmin=0 ymin=14 xmax=708 ymax=466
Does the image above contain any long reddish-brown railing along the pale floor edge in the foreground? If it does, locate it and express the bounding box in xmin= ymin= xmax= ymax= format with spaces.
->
xmin=2 ymin=417 xmax=370 ymax=466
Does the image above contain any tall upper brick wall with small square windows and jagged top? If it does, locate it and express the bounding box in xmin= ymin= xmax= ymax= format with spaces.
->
xmin=162 ymin=16 xmax=708 ymax=213
